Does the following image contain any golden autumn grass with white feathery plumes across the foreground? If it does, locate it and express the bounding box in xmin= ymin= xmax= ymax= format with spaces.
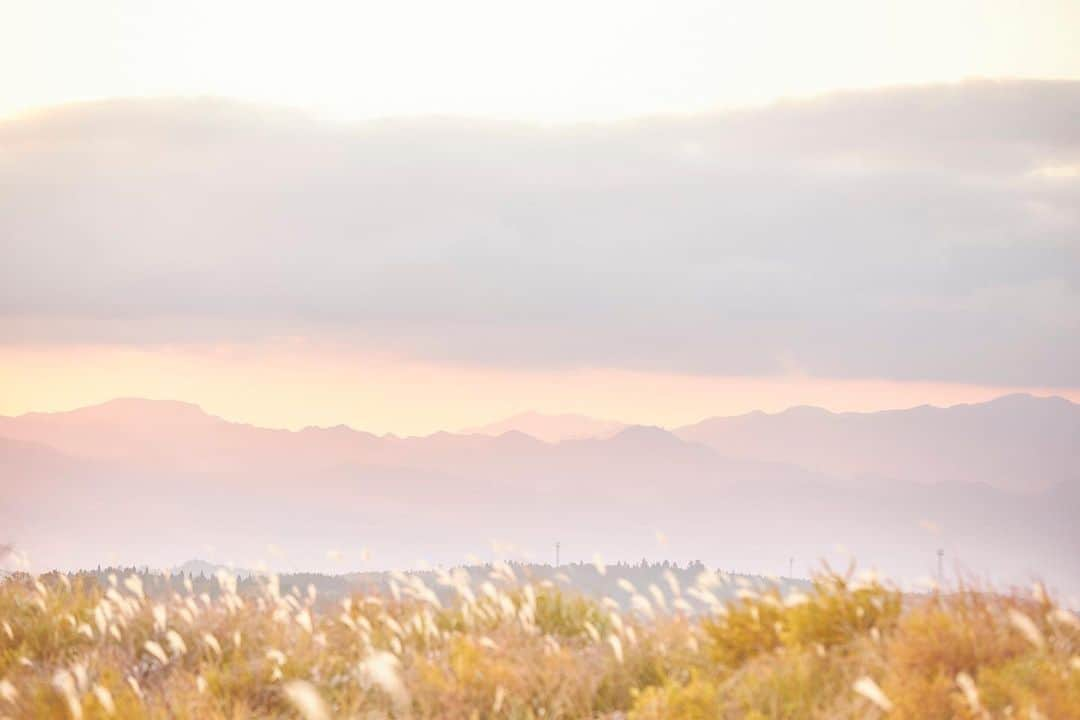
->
xmin=0 ymin=566 xmax=1080 ymax=720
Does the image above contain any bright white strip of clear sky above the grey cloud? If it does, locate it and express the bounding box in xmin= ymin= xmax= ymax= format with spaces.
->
xmin=6 ymin=0 xmax=1080 ymax=122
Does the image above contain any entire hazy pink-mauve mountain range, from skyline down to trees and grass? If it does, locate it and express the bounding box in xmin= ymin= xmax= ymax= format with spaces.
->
xmin=0 ymin=396 xmax=1080 ymax=589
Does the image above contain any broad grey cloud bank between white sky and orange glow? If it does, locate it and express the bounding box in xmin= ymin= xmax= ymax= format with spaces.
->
xmin=0 ymin=81 xmax=1080 ymax=386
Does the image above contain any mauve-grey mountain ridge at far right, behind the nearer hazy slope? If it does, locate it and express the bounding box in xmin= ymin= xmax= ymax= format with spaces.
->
xmin=673 ymin=394 xmax=1080 ymax=492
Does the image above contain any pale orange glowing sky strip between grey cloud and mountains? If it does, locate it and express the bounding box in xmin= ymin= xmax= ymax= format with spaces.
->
xmin=0 ymin=340 xmax=1080 ymax=435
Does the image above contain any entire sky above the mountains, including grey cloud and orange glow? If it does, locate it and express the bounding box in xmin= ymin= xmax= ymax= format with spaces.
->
xmin=0 ymin=0 xmax=1080 ymax=434
